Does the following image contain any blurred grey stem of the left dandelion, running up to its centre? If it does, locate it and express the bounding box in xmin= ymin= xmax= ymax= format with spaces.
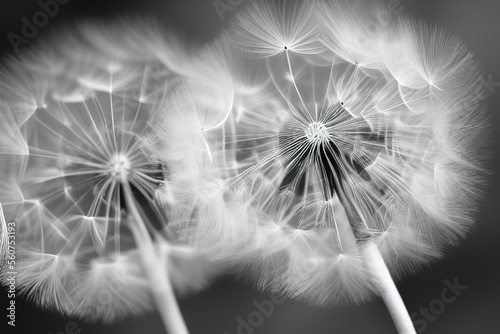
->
xmin=121 ymin=179 xmax=189 ymax=334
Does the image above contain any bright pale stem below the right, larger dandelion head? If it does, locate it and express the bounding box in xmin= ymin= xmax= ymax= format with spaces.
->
xmin=363 ymin=244 xmax=416 ymax=334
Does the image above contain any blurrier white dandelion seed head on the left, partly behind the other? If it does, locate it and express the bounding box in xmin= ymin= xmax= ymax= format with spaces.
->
xmin=0 ymin=21 xmax=214 ymax=322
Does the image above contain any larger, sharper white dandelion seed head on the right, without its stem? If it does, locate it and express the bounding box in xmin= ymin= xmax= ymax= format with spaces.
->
xmin=155 ymin=0 xmax=485 ymax=304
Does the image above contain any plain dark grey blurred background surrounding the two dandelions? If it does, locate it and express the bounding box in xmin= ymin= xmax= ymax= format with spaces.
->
xmin=0 ymin=0 xmax=500 ymax=334
